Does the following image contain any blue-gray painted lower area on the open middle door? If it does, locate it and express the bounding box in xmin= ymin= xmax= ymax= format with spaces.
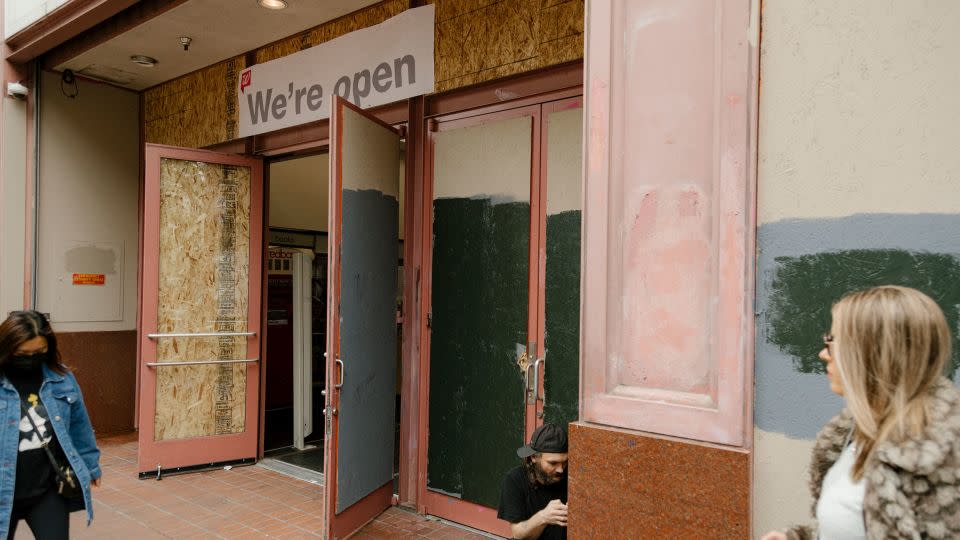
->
xmin=337 ymin=189 xmax=399 ymax=513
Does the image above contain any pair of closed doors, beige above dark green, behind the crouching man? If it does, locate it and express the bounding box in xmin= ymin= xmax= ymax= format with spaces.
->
xmin=423 ymin=96 xmax=583 ymax=536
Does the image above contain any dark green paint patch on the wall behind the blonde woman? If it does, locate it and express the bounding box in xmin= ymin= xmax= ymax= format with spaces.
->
xmin=767 ymin=249 xmax=960 ymax=375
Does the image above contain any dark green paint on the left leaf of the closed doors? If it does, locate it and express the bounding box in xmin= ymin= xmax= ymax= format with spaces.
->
xmin=427 ymin=199 xmax=530 ymax=507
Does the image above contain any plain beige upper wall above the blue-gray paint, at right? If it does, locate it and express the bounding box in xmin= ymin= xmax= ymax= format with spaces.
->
xmin=758 ymin=0 xmax=960 ymax=224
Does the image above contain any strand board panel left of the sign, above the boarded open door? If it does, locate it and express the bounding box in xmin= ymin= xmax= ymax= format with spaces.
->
xmin=143 ymin=56 xmax=246 ymax=148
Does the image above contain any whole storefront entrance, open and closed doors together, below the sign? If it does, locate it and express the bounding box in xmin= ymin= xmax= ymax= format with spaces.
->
xmin=133 ymin=73 xmax=582 ymax=538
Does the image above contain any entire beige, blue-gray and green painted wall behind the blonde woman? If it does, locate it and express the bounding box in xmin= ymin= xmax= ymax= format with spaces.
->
xmin=753 ymin=0 xmax=960 ymax=537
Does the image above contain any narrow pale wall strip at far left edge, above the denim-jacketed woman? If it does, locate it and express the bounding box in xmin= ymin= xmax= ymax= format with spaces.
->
xmin=0 ymin=97 xmax=28 ymax=319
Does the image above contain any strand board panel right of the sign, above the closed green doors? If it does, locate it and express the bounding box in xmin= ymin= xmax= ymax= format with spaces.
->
xmin=433 ymin=0 xmax=584 ymax=92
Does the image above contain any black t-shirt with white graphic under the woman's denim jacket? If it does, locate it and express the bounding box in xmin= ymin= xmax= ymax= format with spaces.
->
xmin=5 ymin=369 xmax=62 ymax=501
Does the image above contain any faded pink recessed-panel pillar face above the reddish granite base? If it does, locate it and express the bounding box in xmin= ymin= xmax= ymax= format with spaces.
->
xmin=581 ymin=0 xmax=758 ymax=445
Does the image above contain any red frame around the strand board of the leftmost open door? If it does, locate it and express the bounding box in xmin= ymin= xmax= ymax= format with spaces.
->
xmin=138 ymin=144 xmax=263 ymax=473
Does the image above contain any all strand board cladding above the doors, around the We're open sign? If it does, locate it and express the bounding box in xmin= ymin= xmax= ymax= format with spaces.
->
xmin=144 ymin=0 xmax=584 ymax=148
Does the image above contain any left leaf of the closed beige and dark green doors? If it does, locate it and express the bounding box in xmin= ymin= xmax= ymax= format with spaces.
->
xmin=425 ymin=106 xmax=540 ymax=535
